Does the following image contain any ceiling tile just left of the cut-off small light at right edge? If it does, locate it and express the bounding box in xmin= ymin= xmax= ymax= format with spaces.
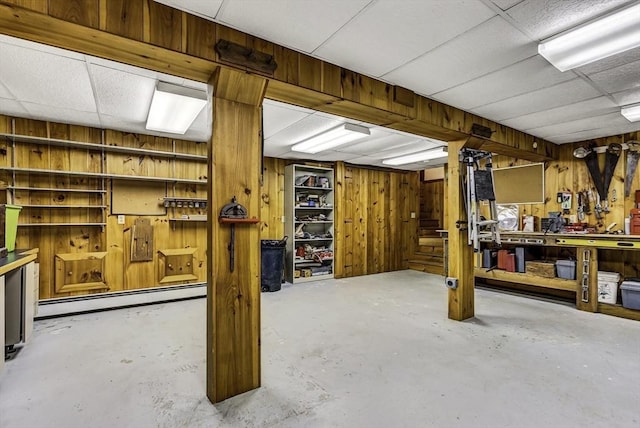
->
xmin=501 ymin=96 xmax=619 ymax=131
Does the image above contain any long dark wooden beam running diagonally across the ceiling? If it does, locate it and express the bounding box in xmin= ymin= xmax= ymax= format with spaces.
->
xmin=0 ymin=0 xmax=558 ymax=161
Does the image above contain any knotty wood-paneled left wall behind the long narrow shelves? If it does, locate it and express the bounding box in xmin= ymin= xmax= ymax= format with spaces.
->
xmin=0 ymin=116 xmax=207 ymax=299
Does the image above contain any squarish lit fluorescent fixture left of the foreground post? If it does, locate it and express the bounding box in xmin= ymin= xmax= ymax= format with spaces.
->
xmin=146 ymin=82 xmax=207 ymax=134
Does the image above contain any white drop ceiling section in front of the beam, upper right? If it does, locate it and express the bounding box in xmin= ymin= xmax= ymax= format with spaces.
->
xmin=159 ymin=0 xmax=640 ymax=144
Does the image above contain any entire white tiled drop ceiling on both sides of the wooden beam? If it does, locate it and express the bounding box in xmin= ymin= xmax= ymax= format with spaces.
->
xmin=0 ymin=0 xmax=640 ymax=170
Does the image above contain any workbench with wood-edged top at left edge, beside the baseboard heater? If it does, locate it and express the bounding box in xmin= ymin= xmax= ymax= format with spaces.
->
xmin=0 ymin=248 xmax=38 ymax=371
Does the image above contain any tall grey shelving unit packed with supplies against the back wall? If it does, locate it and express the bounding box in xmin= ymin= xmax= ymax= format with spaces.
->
xmin=285 ymin=164 xmax=334 ymax=283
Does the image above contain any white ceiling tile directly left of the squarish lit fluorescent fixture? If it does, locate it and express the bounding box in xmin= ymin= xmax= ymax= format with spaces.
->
xmin=89 ymin=64 xmax=156 ymax=122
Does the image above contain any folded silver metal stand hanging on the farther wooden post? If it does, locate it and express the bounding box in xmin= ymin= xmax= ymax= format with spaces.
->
xmin=459 ymin=148 xmax=501 ymax=252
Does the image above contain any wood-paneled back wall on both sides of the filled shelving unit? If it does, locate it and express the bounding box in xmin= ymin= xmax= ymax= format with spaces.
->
xmin=260 ymin=158 xmax=420 ymax=278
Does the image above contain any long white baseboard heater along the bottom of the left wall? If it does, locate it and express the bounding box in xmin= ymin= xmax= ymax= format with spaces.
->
xmin=36 ymin=283 xmax=207 ymax=319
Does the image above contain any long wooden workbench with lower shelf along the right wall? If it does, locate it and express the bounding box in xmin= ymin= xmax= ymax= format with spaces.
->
xmin=474 ymin=232 xmax=640 ymax=320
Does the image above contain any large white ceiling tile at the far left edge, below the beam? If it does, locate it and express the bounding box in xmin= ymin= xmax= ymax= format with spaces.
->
xmin=0 ymin=44 xmax=96 ymax=112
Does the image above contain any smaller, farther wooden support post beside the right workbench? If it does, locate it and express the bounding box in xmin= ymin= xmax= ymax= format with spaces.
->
xmin=447 ymin=140 xmax=474 ymax=321
